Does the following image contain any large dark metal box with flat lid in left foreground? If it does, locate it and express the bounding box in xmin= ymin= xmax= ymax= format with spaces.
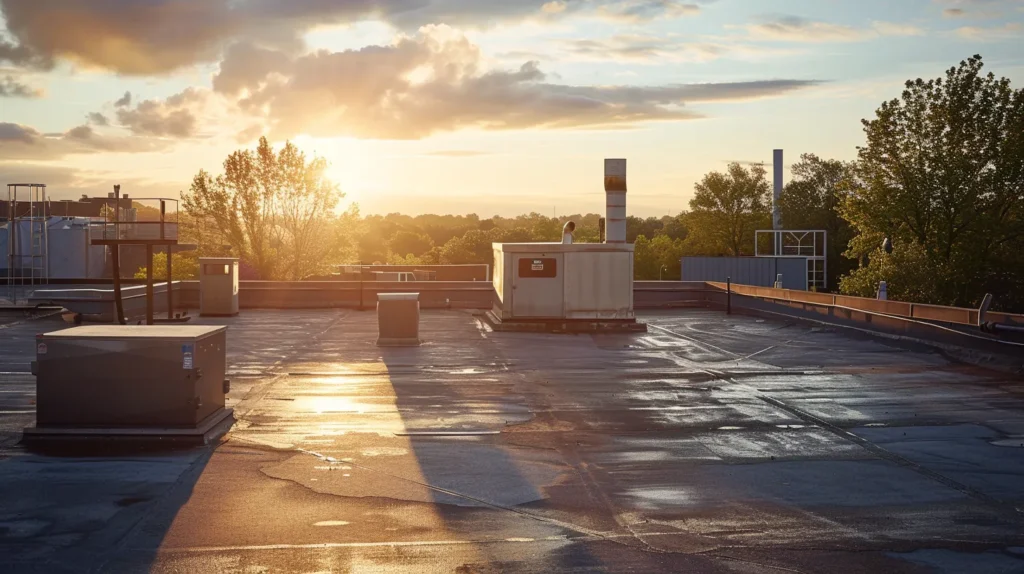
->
xmin=34 ymin=325 xmax=227 ymax=429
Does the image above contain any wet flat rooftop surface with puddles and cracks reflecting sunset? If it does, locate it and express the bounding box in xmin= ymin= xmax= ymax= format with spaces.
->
xmin=0 ymin=310 xmax=1024 ymax=573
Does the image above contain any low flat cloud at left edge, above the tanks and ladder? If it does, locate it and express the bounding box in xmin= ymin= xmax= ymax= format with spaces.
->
xmin=0 ymin=122 xmax=165 ymax=160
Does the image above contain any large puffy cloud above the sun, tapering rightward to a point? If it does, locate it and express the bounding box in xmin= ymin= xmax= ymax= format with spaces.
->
xmin=215 ymin=27 xmax=816 ymax=139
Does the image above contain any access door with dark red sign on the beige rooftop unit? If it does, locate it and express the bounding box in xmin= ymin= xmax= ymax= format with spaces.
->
xmin=512 ymin=254 xmax=565 ymax=319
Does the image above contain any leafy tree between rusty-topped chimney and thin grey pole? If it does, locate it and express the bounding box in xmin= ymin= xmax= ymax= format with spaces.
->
xmin=686 ymin=163 xmax=771 ymax=256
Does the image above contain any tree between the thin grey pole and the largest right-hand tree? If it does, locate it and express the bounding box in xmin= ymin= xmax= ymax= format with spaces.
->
xmin=779 ymin=153 xmax=856 ymax=289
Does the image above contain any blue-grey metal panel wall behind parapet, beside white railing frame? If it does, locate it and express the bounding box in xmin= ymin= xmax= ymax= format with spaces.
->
xmin=681 ymin=257 xmax=807 ymax=291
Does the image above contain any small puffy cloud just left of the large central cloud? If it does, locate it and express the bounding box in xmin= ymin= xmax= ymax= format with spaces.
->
xmin=115 ymin=88 xmax=206 ymax=138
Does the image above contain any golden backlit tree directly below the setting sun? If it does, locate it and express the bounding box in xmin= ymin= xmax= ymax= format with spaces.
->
xmin=183 ymin=137 xmax=344 ymax=279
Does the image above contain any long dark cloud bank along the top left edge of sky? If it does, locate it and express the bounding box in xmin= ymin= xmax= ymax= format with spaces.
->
xmin=0 ymin=0 xmax=709 ymax=75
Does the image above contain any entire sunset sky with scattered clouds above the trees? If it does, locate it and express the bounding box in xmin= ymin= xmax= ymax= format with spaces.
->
xmin=0 ymin=0 xmax=1024 ymax=217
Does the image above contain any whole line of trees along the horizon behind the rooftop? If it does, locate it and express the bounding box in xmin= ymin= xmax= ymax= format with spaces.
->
xmin=163 ymin=56 xmax=1024 ymax=310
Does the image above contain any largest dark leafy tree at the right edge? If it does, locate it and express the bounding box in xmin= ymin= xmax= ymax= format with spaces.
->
xmin=842 ymin=56 xmax=1024 ymax=309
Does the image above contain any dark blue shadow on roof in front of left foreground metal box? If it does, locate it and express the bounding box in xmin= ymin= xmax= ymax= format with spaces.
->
xmin=0 ymin=433 xmax=213 ymax=573
